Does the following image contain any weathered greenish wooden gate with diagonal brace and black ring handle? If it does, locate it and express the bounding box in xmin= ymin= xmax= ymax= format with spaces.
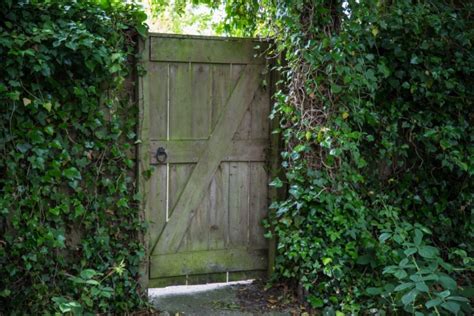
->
xmin=140 ymin=34 xmax=270 ymax=287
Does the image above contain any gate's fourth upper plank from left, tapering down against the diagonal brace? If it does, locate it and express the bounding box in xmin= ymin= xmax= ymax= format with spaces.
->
xmin=211 ymin=65 xmax=234 ymax=129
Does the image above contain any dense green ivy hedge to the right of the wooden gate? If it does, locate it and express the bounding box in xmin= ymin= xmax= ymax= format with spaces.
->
xmin=260 ymin=0 xmax=474 ymax=315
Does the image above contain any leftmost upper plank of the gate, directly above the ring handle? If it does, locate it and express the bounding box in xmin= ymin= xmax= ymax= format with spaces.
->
xmin=148 ymin=62 xmax=168 ymax=140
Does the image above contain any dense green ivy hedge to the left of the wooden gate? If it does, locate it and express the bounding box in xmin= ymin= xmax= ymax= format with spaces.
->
xmin=0 ymin=0 xmax=145 ymax=314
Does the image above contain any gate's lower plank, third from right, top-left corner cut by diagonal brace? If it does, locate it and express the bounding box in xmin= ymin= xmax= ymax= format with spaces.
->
xmin=209 ymin=162 xmax=230 ymax=250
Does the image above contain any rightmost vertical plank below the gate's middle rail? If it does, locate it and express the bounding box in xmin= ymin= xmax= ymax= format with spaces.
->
xmin=249 ymin=162 xmax=268 ymax=249
